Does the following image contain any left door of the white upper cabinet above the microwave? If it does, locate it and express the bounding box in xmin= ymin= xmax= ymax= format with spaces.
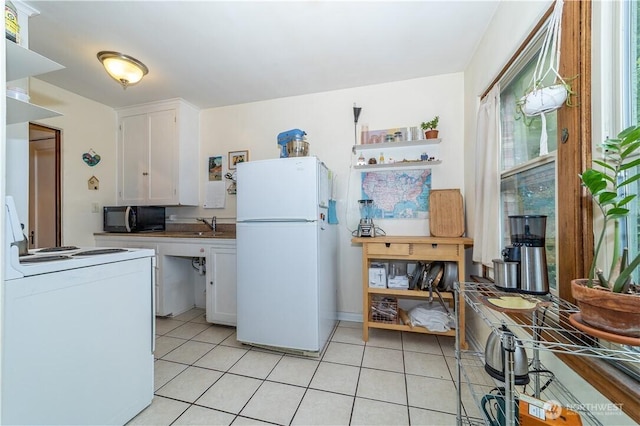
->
xmin=118 ymin=114 xmax=149 ymax=205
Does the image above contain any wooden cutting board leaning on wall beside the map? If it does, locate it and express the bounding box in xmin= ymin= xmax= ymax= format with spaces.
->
xmin=429 ymin=189 xmax=464 ymax=237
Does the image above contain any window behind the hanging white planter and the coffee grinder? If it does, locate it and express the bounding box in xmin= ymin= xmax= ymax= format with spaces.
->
xmin=500 ymin=30 xmax=557 ymax=290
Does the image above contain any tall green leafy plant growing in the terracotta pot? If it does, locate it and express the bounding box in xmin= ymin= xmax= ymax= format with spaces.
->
xmin=579 ymin=126 xmax=640 ymax=293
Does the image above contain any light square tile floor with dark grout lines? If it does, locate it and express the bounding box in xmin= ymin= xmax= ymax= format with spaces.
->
xmin=129 ymin=309 xmax=478 ymax=425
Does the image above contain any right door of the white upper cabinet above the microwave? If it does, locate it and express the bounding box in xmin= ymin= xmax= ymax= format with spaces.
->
xmin=147 ymin=110 xmax=178 ymax=205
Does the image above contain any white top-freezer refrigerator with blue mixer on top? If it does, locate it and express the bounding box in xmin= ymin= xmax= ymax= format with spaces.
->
xmin=236 ymin=157 xmax=337 ymax=355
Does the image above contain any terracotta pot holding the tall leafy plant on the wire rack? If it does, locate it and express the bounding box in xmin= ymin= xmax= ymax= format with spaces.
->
xmin=571 ymin=278 xmax=640 ymax=337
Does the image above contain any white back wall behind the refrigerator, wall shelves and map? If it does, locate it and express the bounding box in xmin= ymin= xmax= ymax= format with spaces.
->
xmin=170 ymin=73 xmax=464 ymax=319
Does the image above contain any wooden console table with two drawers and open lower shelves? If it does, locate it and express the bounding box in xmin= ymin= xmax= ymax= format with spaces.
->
xmin=351 ymin=237 xmax=473 ymax=349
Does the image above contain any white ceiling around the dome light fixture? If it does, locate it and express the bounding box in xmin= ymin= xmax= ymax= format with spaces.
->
xmin=28 ymin=0 xmax=499 ymax=108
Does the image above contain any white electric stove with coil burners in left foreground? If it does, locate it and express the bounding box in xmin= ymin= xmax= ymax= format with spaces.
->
xmin=0 ymin=197 xmax=155 ymax=424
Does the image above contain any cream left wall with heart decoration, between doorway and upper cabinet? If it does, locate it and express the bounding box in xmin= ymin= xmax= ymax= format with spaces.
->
xmin=28 ymin=78 xmax=116 ymax=246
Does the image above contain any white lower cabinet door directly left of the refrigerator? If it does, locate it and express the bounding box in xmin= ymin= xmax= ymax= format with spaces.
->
xmin=206 ymin=248 xmax=236 ymax=326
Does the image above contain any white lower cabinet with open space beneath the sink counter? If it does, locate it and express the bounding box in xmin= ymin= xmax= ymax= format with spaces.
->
xmin=95 ymin=233 xmax=236 ymax=326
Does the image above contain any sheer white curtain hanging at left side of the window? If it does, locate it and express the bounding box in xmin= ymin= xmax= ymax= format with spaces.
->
xmin=473 ymin=84 xmax=501 ymax=267
